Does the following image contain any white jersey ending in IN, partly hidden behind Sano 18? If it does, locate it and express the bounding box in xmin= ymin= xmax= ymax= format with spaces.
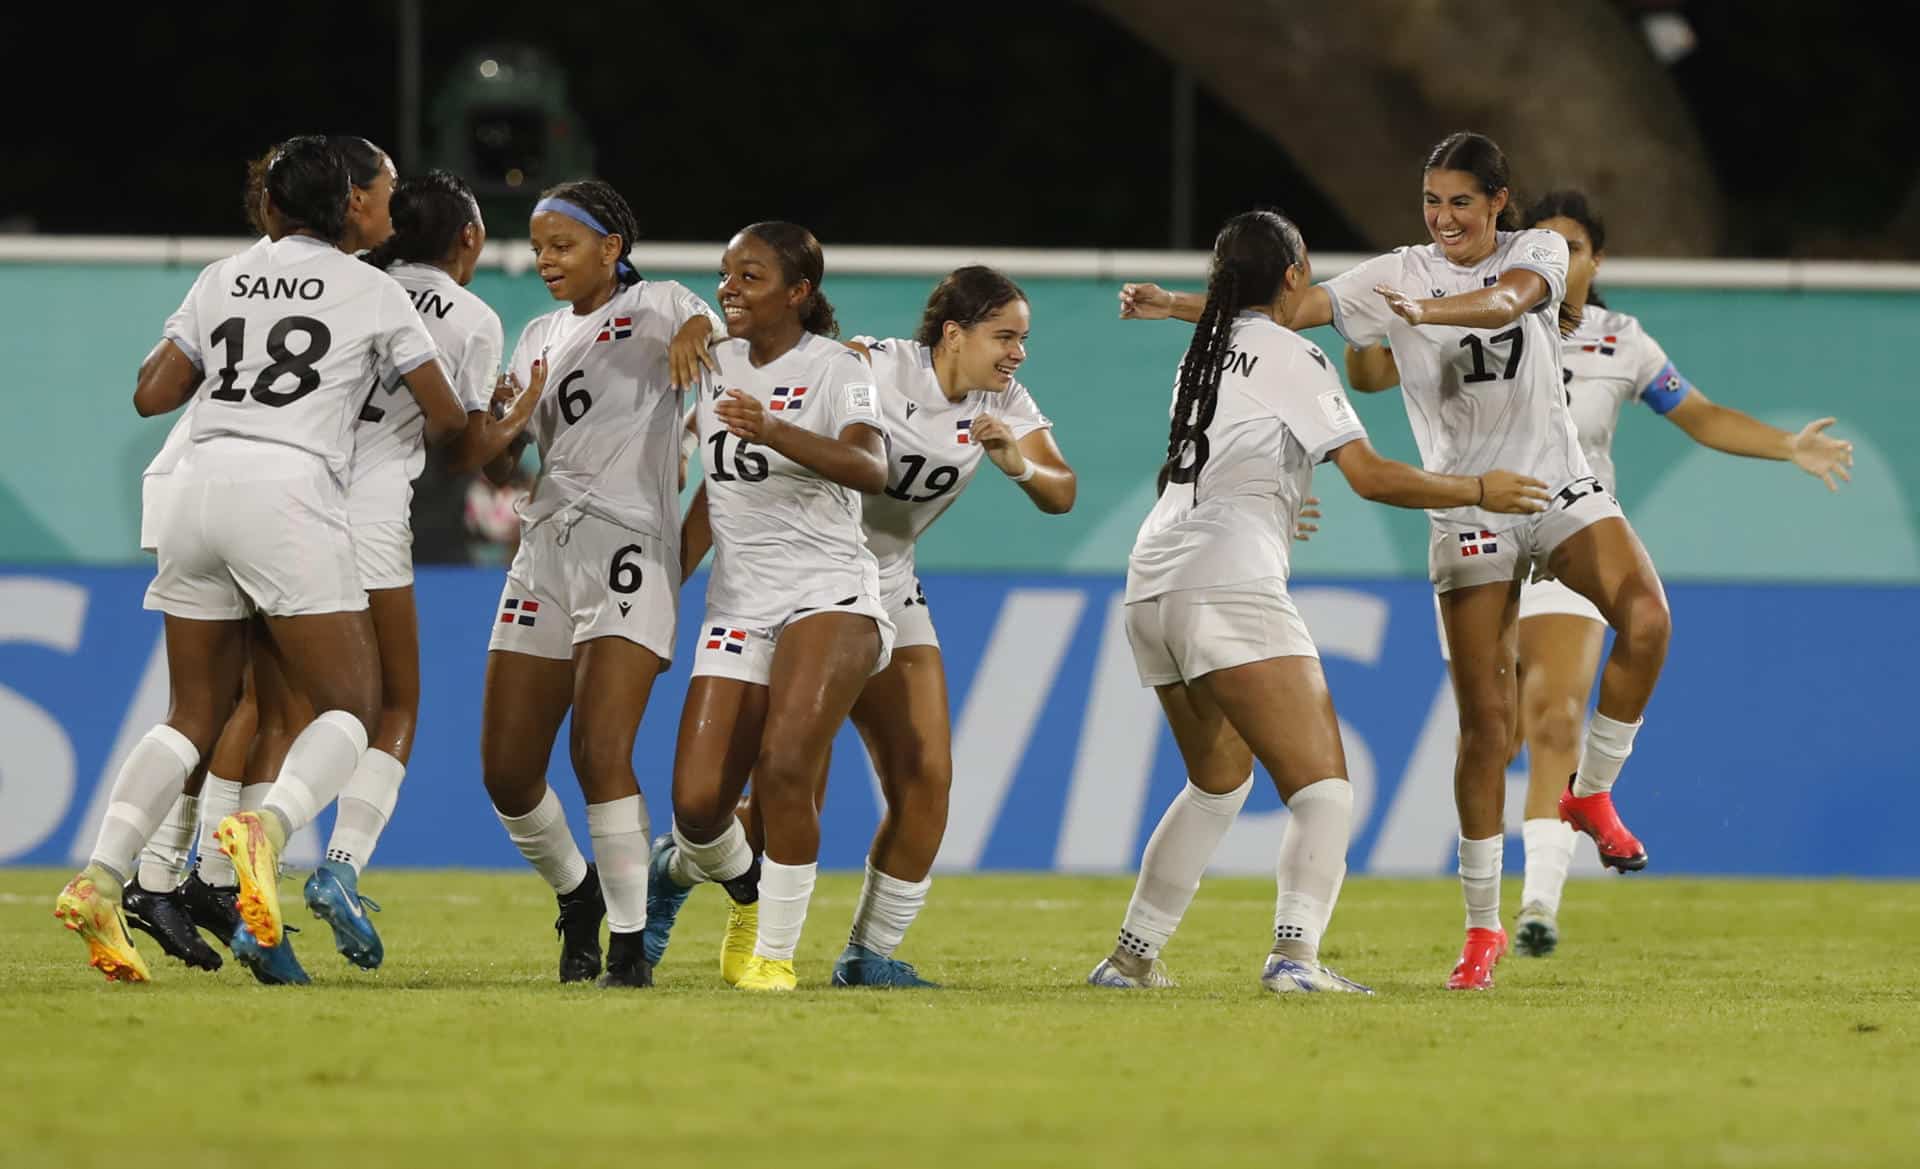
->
xmin=353 ymin=263 xmax=505 ymax=506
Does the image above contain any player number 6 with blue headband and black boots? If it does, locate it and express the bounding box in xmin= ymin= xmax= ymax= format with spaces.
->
xmin=468 ymin=180 xmax=712 ymax=987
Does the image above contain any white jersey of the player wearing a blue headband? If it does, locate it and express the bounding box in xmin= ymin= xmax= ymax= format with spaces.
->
xmin=513 ymin=280 xmax=726 ymax=549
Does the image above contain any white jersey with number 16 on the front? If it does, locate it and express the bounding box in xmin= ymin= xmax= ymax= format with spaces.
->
xmin=695 ymin=334 xmax=887 ymax=628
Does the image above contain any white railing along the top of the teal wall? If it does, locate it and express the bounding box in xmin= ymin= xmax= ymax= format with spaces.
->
xmin=0 ymin=236 xmax=1920 ymax=292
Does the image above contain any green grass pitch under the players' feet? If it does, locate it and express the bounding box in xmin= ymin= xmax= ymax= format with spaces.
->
xmin=0 ymin=870 xmax=1920 ymax=1169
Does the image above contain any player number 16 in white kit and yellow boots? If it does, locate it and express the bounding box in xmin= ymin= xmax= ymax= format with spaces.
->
xmin=655 ymin=223 xmax=895 ymax=990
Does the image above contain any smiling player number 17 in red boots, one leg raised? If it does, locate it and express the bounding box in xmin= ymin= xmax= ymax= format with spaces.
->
xmin=1121 ymin=132 xmax=1670 ymax=989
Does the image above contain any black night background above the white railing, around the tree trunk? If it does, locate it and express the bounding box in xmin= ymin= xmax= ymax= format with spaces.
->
xmin=0 ymin=0 xmax=1920 ymax=257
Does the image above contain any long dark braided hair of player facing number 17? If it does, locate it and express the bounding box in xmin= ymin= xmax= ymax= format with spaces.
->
xmin=1156 ymin=211 xmax=1308 ymax=493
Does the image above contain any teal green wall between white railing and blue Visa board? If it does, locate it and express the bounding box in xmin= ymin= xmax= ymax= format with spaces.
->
xmin=0 ymin=263 xmax=1920 ymax=584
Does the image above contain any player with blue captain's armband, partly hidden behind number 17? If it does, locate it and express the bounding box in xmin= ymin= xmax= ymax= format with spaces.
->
xmin=1348 ymin=190 xmax=1853 ymax=956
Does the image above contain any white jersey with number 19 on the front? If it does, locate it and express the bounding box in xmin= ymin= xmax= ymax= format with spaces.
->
xmin=854 ymin=338 xmax=1052 ymax=597
